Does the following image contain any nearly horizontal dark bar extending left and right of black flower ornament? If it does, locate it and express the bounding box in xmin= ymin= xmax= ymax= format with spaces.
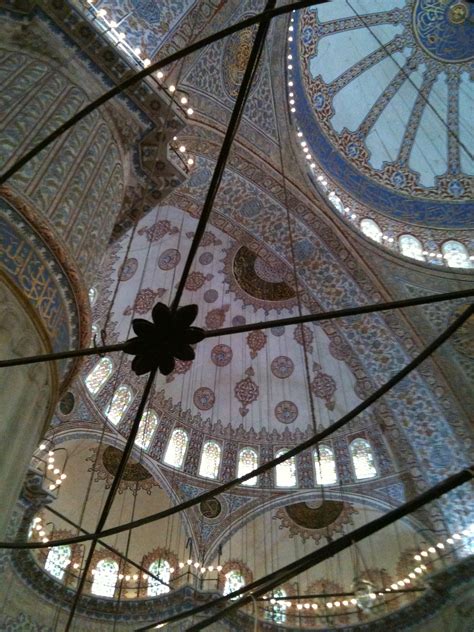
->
xmin=0 ymin=288 xmax=474 ymax=369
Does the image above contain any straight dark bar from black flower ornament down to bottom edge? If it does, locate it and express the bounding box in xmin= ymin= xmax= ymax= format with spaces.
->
xmin=61 ymin=369 xmax=157 ymax=632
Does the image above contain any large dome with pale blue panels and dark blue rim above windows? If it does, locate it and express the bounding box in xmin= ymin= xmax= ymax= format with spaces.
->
xmin=288 ymin=0 xmax=474 ymax=254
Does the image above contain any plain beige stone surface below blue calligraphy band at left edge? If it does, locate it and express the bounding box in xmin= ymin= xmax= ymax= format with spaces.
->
xmin=0 ymin=275 xmax=57 ymax=540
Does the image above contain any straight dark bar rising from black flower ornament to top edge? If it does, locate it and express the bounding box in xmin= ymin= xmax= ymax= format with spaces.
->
xmin=171 ymin=0 xmax=276 ymax=312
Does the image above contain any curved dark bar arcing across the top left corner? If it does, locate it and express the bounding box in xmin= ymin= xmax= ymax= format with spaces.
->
xmin=0 ymin=0 xmax=329 ymax=185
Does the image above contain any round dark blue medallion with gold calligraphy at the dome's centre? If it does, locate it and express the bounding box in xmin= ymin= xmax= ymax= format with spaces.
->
xmin=413 ymin=0 xmax=474 ymax=63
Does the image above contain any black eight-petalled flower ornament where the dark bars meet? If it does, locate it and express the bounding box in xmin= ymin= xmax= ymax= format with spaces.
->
xmin=124 ymin=303 xmax=205 ymax=375
